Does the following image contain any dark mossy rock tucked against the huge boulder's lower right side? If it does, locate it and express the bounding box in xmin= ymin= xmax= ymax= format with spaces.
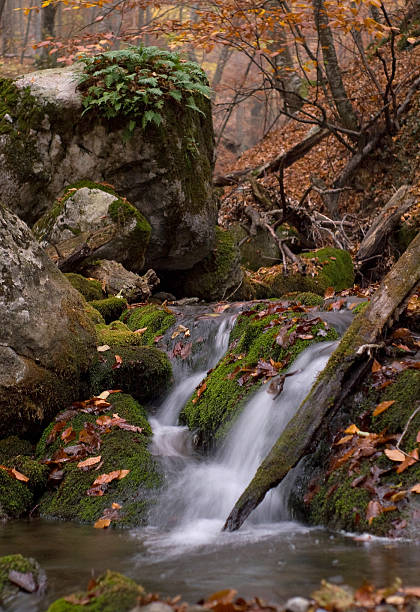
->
xmin=175 ymin=227 xmax=243 ymax=301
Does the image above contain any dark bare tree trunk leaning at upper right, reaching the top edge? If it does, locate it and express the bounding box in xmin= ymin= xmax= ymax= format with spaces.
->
xmin=312 ymin=0 xmax=359 ymax=131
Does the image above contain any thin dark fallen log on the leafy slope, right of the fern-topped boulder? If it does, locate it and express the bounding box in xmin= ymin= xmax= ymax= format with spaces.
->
xmin=213 ymin=128 xmax=331 ymax=187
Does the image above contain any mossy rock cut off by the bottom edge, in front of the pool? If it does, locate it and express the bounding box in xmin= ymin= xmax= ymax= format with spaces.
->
xmin=47 ymin=570 xmax=144 ymax=612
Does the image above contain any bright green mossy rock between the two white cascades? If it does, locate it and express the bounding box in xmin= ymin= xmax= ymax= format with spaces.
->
xmin=180 ymin=302 xmax=337 ymax=448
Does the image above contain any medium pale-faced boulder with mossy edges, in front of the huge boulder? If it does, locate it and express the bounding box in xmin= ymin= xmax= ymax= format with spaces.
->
xmin=33 ymin=181 xmax=151 ymax=272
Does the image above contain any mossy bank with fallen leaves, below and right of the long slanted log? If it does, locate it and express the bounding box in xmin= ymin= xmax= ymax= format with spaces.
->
xmin=306 ymin=369 xmax=420 ymax=535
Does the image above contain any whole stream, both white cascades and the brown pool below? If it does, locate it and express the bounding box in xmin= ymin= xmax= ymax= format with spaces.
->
xmin=0 ymin=308 xmax=420 ymax=612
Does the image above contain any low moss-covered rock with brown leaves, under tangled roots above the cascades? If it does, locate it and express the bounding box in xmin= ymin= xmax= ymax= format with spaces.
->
xmin=248 ymin=247 xmax=354 ymax=298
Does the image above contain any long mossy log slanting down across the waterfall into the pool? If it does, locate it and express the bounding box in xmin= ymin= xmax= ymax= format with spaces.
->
xmin=224 ymin=233 xmax=420 ymax=531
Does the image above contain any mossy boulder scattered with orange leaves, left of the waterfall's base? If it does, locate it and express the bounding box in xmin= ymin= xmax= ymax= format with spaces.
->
xmin=37 ymin=393 xmax=162 ymax=526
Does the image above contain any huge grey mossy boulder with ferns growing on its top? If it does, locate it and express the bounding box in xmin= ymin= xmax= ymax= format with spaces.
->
xmin=0 ymin=49 xmax=217 ymax=270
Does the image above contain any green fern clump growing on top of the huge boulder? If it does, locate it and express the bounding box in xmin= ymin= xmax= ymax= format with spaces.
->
xmin=78 ymin=46 xmax=211 ymax=136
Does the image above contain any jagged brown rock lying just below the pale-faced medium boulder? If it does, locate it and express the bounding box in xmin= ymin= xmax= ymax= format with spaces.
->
xmin=83 ymin=260 xmax=160 ymax=304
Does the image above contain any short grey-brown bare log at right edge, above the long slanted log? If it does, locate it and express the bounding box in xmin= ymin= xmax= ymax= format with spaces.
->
xmin=356 ymin=185 xmax=416 ymax=264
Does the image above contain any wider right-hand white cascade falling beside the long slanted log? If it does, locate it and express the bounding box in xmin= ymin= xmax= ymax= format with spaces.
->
xmin=149 ymin=342 xmax=337 ymax=546
